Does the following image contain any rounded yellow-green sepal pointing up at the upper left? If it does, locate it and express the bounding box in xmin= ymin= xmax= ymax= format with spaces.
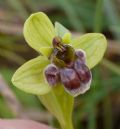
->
xmin=23 ymin=12 xmax=55 ymax=52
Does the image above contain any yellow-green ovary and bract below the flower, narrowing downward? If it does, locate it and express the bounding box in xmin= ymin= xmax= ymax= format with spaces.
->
xmin=38 ymin=85 xmax=74 ymax=129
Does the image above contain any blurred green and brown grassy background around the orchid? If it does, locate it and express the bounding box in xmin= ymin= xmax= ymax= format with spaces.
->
xmin=0 ymin=0 xmax=120 ymax=129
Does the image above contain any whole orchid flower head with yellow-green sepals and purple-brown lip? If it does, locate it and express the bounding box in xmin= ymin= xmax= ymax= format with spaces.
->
xmin=12 ymin=12 xmax=107 ymax=96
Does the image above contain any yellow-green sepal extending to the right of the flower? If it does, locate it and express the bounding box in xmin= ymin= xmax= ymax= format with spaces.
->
xmin=70 ymin=33 xmax=107 ymax=69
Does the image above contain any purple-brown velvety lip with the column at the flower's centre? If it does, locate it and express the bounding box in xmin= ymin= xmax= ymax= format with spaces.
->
xmin=45 ymin=37 xmax=91 ymax=96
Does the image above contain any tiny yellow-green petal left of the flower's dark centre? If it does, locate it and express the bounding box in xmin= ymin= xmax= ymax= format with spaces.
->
xmin=39 ymin=47 xmax=53 ymax=57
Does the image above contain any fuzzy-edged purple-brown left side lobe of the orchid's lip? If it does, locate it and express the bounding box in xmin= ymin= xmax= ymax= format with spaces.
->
xmin=44 ymin=64 xmax=59 ymax=86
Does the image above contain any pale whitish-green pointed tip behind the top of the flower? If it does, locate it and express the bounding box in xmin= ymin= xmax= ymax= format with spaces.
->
xmin=55 ymin=22 xmax=70 ymax=38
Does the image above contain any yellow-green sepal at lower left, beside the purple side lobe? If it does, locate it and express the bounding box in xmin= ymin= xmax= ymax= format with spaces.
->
xmin=12 ymin=56 xmax=51 ymax=95
